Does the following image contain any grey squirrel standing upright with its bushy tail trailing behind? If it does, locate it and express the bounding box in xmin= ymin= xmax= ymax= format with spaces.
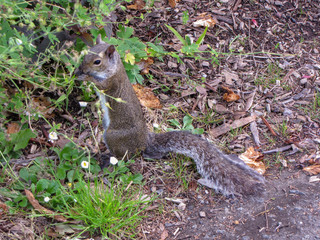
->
xmin=76 ymin=35 xmax=265 ymax=196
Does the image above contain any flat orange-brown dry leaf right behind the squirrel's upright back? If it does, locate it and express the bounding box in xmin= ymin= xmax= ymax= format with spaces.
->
xmin=132 ymin=84 xmax=162 ymax=109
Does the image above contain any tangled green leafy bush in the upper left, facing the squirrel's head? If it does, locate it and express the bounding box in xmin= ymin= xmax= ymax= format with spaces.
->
xmin=0 ymin=0 xmax=122 ymax=123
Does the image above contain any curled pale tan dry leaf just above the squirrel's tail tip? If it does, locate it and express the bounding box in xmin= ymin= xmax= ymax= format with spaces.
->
xmin=239 ymin=147 xmax=266 ymax=174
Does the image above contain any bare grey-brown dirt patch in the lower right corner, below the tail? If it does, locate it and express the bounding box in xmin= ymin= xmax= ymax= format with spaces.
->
xmin=158 ymin=170 xmax=320 ymax=240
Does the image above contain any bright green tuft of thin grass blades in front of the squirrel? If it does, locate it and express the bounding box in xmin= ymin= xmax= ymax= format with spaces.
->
xmin=64 ymin=180 xmax=151 ymax=239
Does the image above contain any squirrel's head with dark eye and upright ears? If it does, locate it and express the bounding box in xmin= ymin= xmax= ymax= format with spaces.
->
xmin=75 ymin=35 xmax=122 ymax=90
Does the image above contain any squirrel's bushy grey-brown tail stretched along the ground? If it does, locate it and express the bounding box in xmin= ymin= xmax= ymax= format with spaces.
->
xmin=144 ymin=131 xmax=265 ymax=196
